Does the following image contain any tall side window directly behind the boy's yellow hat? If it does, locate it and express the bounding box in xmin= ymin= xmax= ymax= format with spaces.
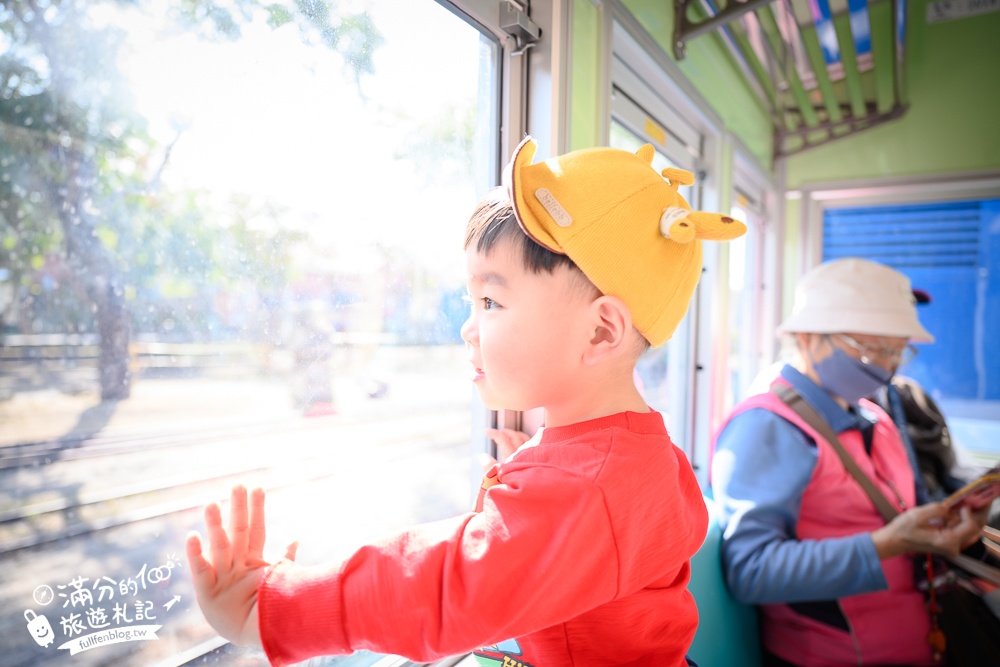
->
xmin=609 ymin=16 xmax=725 ymax=474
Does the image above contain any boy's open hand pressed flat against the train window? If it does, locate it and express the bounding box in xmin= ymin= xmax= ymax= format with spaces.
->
xmin=187 ymin=486 xmax=297 ymax=646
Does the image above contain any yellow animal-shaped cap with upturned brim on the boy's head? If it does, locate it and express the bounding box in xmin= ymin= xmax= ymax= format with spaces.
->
xmin=504 ymin=137 xmax=746 ymax=347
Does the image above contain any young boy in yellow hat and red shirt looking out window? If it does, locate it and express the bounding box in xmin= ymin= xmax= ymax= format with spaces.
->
xmin=187 ymin=137 xmax=745 ymax=667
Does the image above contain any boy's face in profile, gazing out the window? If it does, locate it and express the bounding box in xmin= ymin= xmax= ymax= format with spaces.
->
xmin=462 ymin=237 xmax=599 ymax=410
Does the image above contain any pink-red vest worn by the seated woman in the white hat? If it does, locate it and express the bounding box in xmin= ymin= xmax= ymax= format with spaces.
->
xmin=727 ymin=380 xmax=936 ymax=666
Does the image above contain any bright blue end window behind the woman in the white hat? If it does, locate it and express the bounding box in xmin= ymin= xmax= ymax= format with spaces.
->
xmin=823 ymin=199 xmax=1000 ymax=465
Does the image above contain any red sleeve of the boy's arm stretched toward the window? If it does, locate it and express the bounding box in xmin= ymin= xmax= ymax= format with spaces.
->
xmin=258 ymin=468 xmax=619 ymax=665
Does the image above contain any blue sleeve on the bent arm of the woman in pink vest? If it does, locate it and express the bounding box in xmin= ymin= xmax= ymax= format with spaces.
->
xmin=712 ymin=408 xmax=888 ymax=604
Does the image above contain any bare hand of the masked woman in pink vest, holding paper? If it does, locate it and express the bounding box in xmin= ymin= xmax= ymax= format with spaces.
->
xmin=872 ymin=503 xmax=986 ymax=560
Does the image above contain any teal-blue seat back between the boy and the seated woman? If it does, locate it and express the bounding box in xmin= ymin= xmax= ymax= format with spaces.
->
xmin=688 ymin=498 xmax=761 ymax=667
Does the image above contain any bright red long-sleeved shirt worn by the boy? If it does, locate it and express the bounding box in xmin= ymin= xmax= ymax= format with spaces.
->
xmin=258 ymin=412 xmax=708 ymax=667
